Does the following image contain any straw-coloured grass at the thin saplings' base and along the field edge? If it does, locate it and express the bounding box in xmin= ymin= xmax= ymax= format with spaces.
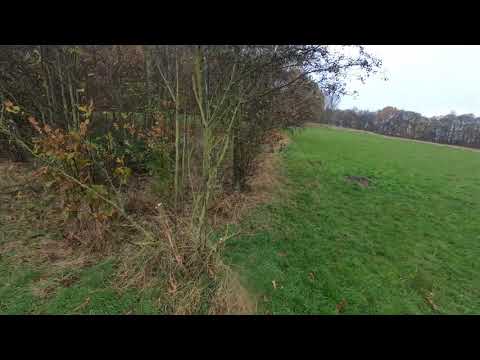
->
xmin=118 ymin=128 xmax=289 ymax=314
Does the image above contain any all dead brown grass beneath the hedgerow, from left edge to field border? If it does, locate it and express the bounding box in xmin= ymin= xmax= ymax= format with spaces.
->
xmin=0 ymin=128 xmax=289 ymax=314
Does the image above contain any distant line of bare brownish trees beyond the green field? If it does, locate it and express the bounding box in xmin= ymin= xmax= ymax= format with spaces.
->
xmin=322 ymin=107 xmax=480 ymax=148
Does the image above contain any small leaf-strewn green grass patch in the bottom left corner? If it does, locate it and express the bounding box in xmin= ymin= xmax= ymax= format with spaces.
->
xmin=0 ymin=260 xmax=159 ymax=315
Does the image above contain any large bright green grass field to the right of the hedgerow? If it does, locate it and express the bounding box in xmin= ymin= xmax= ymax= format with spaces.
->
xmin=227 ymin=128 xmax=480 ymax=314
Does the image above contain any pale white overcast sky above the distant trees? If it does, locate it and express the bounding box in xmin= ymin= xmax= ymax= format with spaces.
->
xmin=339 ymin=45 xmax=480 ymax=116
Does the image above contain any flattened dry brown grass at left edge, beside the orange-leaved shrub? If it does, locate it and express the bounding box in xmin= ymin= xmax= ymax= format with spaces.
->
xmin=0 ymin=162 xmax=95 ymax=270
